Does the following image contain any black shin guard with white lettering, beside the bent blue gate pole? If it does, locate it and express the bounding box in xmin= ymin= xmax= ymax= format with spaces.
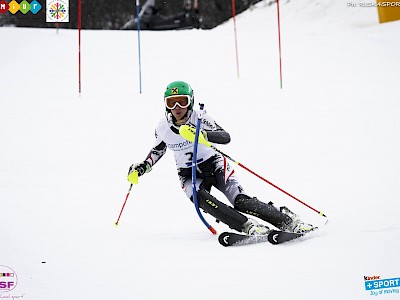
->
xmin=197 ymin=189 xmax=248 ymax=232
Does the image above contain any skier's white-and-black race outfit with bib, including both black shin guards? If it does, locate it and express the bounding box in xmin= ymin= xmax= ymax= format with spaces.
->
xmin=146 ymin=111 xmax=292 ymax=231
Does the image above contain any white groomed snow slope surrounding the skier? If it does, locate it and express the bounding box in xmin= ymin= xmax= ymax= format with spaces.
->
xmin=0 ymin=0 xmax=400 ymax=300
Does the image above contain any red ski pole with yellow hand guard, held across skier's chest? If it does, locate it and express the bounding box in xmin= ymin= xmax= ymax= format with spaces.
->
xmin=179 ymin=125 xmax=327 ymax=218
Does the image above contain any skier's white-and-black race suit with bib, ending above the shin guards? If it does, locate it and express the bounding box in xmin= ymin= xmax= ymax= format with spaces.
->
xmin=146 ymin=111 xmax=243 ymax=205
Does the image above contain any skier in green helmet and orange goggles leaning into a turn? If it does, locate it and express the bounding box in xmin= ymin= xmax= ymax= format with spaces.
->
xmin=128 ymin=81 xmax=315 ymax=235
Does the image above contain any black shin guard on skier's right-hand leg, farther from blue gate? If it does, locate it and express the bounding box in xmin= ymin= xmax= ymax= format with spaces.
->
xmin=235 ymin=194 xmax=292 ymax=229
